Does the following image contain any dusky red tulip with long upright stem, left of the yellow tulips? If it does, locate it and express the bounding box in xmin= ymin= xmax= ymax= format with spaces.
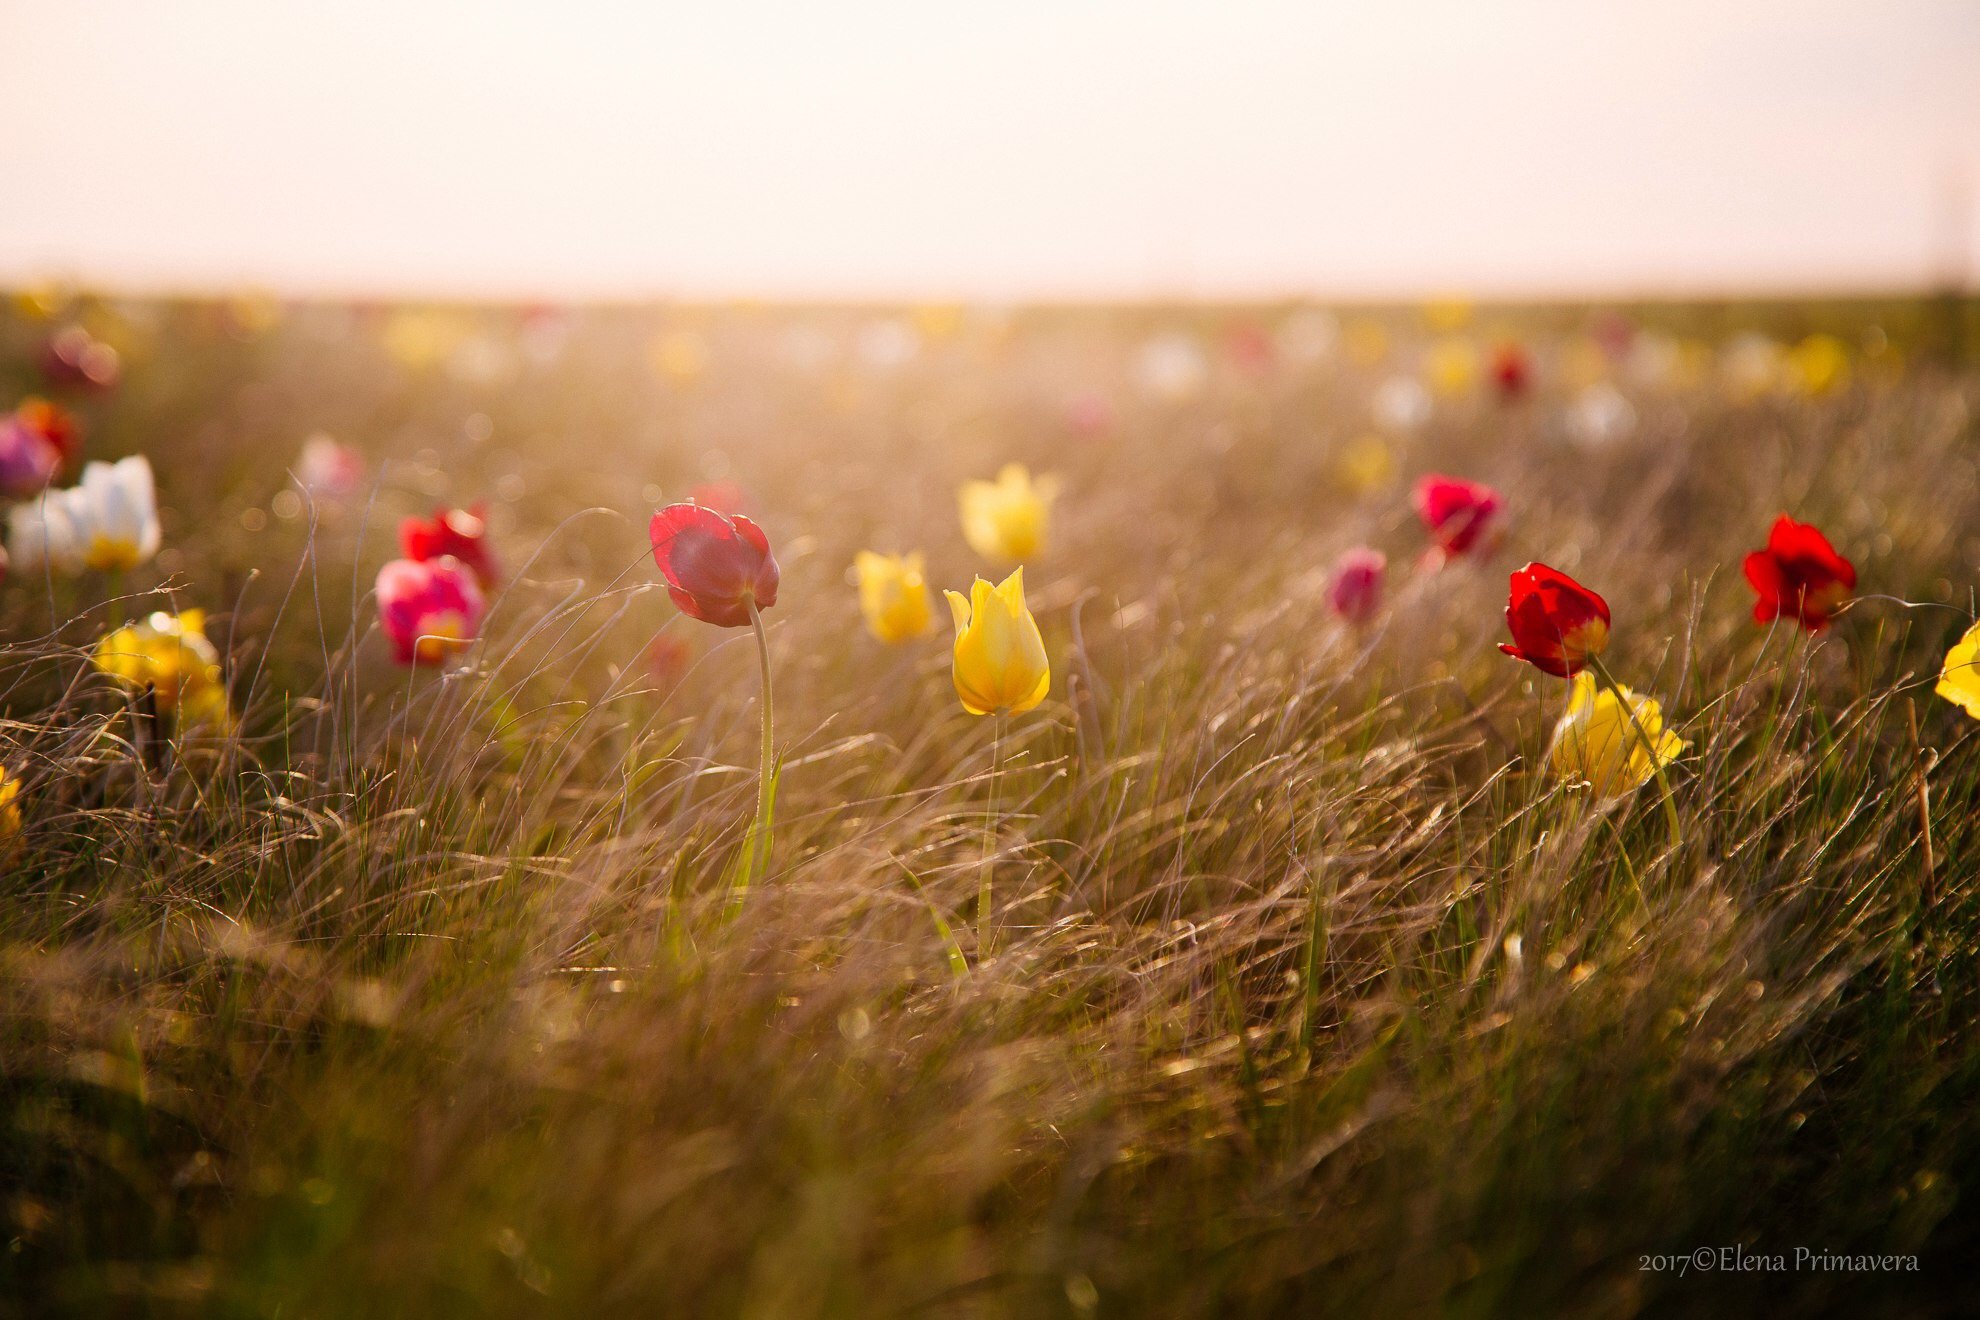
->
xmin=647 ymin=503 xmax=778 ymax=898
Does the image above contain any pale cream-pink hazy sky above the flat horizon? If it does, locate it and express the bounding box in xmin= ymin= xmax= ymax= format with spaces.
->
xmin=0 ymin=0 xmax=1980 ymax=297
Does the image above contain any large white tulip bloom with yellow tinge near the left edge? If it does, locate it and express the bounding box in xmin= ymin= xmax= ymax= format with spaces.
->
xmin=8 ymin=455 xmax=162 ymax=574
